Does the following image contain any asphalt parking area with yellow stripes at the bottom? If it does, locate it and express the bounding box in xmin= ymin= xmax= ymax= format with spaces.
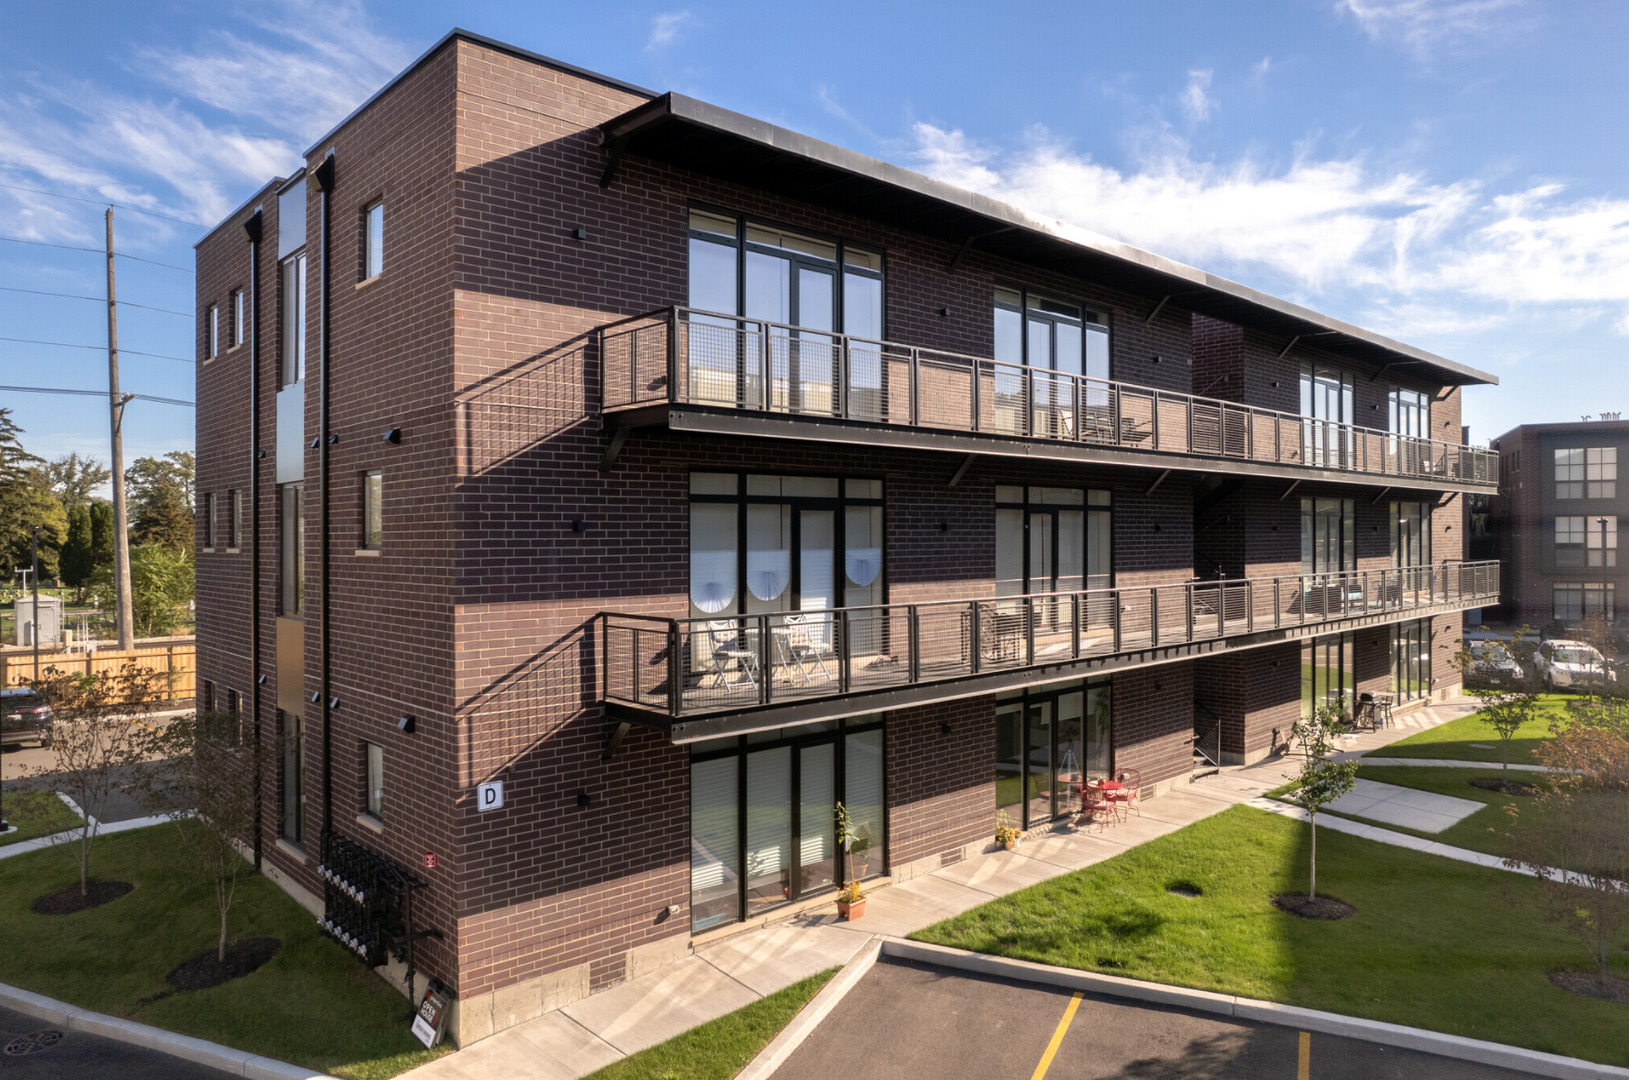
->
xmin=775 ymin=961 xmax=1550 ymax=1080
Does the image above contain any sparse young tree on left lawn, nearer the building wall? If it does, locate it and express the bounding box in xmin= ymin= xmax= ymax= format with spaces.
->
xmin=143 ymin=712 xmax=264 ymax=963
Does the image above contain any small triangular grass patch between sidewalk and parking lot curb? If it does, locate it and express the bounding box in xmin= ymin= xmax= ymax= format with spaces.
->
xmin=583 ymin=968 xmax=837 ymax=1080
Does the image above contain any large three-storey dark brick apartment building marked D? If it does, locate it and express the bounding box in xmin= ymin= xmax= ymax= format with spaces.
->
xmin=197 ymin=31 xmax=1499 ymax=1043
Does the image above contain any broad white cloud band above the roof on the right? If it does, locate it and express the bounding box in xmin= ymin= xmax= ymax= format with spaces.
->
xmin=914 ymin=124 xmax=1629 ymax=334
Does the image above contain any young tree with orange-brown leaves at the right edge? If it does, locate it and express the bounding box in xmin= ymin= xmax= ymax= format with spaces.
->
xmin=1505 ymin=699 xmax=1629 ymax=992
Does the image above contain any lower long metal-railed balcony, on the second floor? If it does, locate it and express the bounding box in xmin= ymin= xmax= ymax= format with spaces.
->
xmin=599 ymin=562 xmax=1499 ymax=741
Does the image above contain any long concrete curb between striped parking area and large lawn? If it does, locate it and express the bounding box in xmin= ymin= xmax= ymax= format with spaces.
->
xmin=881 ymin=938 xmax=1629 ymax=1080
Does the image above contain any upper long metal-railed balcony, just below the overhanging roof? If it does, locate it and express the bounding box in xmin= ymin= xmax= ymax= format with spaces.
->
xmin=599 ymin=308 xmax=1499 ymax=490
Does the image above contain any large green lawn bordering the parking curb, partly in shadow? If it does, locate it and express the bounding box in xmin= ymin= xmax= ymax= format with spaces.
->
xmin=912 ymin=806 xmax=1629 ymax=1065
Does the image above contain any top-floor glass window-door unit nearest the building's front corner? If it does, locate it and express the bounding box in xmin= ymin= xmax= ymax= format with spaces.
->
xmin=686 ymin=210 xmax=886 ymax=419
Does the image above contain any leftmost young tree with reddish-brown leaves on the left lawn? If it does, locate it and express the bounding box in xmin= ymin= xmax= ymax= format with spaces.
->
xmin=24 ymin=661 xmax=169 ymax=896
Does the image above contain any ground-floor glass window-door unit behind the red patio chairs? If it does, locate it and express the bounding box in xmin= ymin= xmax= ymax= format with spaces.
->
xmin=995 ymin=679 xmax=1114 ymax=829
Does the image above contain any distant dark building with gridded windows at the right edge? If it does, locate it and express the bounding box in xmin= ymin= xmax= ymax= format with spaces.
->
xmin=1487 ymin=412 xmax=1629 ymax=629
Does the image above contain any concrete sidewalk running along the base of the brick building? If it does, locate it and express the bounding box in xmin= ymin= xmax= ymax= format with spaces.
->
xmin=409 ymin=697 xmax=1478 ymax=1080
